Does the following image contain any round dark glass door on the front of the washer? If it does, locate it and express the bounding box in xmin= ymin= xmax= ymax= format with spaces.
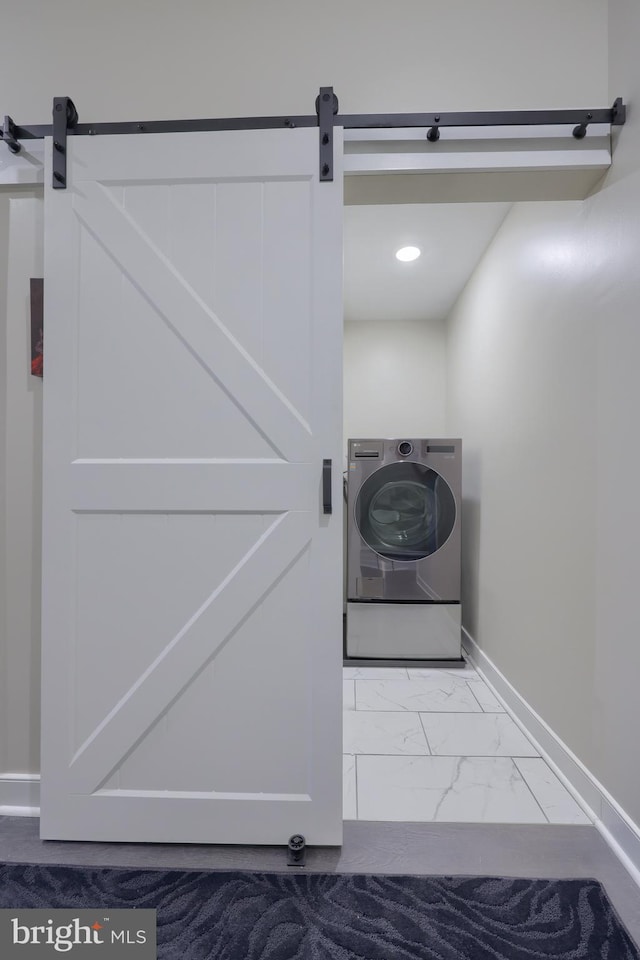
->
xmin=355 ymin=460 xmax=456 ymax=561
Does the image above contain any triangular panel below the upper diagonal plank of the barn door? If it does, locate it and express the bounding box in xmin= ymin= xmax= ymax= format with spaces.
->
xmin=77 ymin=231 xmax=278 ymax=459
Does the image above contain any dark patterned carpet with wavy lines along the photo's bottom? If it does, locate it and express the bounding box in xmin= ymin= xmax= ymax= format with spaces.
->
xmin=0 ymin=864 xmax=640 ymax=960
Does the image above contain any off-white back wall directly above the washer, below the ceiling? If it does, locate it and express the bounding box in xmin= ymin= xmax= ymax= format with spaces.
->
xmin=344 ymin=320 xmax=446 ymax=453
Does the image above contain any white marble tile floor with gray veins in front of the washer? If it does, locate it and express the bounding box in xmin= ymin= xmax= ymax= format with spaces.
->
xmin=343 ymin=664 xmax=591 ymax=824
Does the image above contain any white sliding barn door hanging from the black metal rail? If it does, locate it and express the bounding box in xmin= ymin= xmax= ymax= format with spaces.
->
xmin=41 ymin=129 xmax=342 ymax=844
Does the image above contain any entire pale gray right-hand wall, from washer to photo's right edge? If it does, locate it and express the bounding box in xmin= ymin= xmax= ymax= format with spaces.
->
xmin=448 ymin=0 xmax=640 ymax=823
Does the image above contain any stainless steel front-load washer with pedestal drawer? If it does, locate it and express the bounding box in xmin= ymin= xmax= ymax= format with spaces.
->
xmin=347 ymin=438 xmax=462 ymax=660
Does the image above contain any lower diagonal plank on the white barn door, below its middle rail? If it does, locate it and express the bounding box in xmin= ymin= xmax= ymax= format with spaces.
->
xmin=69 ymin=512 xmax=311 ymax=792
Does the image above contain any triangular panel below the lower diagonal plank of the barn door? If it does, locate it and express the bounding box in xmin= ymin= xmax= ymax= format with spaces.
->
xmin=110 ymin=553 xmax=312 ymax=794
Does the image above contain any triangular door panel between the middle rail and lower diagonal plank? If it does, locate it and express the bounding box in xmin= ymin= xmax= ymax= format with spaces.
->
xmin=72 ymin=513 xmax=265 ymax=752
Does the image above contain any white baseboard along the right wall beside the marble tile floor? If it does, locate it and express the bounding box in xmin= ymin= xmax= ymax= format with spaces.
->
xmin=462 ymin=627 xmax=640 ymax=886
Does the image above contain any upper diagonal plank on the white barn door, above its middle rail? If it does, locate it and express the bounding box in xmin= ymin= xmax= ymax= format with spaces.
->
xmin=73 ymin=181 xmax=311 ymax=460
